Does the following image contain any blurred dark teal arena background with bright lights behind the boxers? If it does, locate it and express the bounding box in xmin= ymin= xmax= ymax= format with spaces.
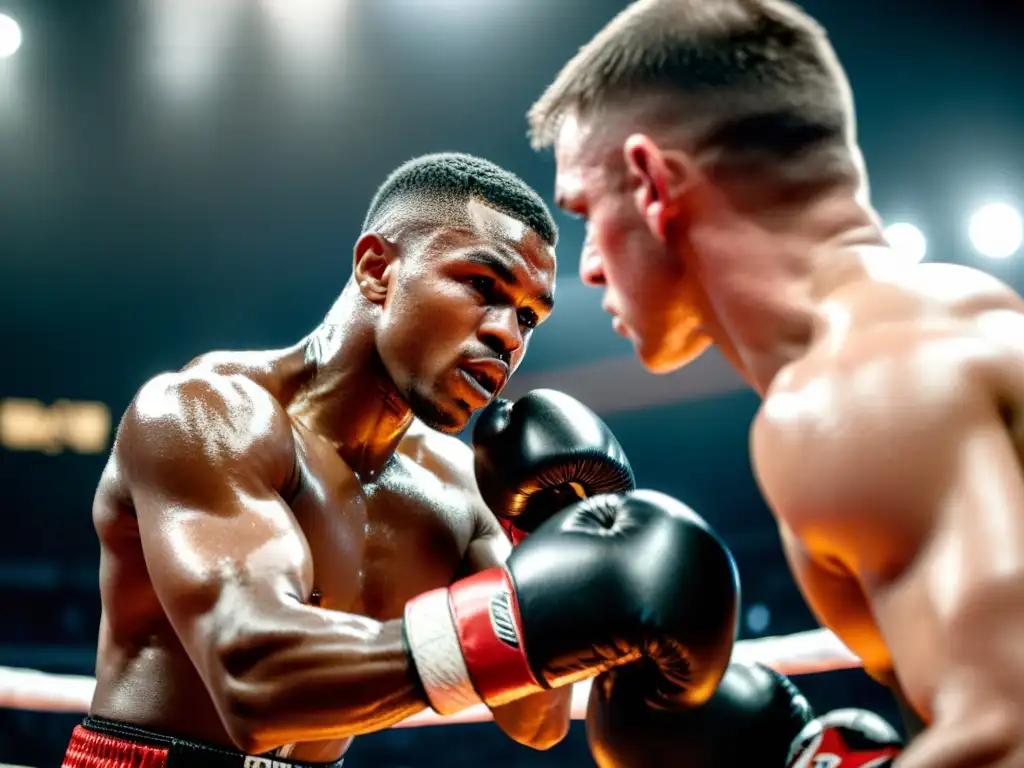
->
xmin=0 ymin=0 xmax=1024 ymax=768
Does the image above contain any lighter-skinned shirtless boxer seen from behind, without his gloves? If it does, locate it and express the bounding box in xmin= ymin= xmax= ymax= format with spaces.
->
xmin=530 ymin=0 xmax=1024 ymax=768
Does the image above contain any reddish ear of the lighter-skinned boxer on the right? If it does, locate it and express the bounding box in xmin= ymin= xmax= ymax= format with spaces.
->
xmin=623 ymin=133 xmax=697 ymax=242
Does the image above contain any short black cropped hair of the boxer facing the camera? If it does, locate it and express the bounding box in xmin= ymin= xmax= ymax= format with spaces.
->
xmin=362 ymin=153 xmax=558 ymax=247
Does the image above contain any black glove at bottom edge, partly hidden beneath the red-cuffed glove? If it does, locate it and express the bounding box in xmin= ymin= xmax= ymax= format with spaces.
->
xmin=587 ymin=664 xmax=813 ymax=768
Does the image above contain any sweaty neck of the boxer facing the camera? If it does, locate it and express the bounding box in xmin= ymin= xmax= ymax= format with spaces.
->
xmin=289 ymin=288 xmax=413 ymax=479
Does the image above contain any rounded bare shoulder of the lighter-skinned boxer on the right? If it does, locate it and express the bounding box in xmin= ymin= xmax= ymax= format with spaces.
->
xmin=753 ymin=324 xmax=1009 ymax=551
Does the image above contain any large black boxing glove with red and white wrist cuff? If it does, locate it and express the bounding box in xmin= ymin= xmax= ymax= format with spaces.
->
xmin=403 ymin=490 xmax=738 ymax=715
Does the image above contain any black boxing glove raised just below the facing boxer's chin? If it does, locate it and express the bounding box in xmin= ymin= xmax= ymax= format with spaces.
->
xmin=473 ymin=389 xmax=635 ymax=544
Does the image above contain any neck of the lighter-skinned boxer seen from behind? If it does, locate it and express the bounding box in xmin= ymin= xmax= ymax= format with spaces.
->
xmin=696 ymin=185 xmax=885 ymax=396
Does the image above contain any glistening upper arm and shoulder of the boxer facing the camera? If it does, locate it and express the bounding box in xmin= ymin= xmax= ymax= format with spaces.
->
xmin=117 ymin=375 xmax=312 ymax=680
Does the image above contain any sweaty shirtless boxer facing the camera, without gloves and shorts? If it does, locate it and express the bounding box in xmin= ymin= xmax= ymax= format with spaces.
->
xmin=79 ymin=156 xmax=569 ymax=761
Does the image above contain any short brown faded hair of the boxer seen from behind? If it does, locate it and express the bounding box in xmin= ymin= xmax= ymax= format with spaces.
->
xmin=528 ymin=0 xmax=854 ymax=171
